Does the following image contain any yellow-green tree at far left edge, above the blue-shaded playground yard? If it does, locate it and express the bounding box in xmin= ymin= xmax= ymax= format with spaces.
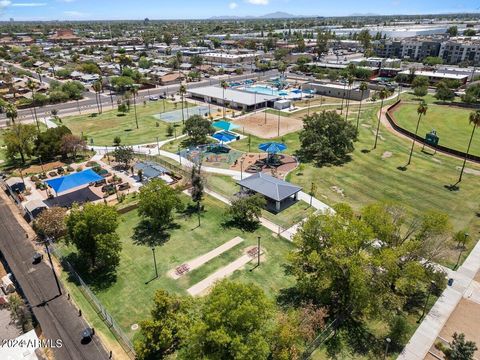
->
xmin=3 ymin=124 xmax=37 ymax=163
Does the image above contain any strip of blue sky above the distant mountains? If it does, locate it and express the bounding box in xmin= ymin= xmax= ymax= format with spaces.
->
xmin=0 ymin=0 xmax=480 ymax=20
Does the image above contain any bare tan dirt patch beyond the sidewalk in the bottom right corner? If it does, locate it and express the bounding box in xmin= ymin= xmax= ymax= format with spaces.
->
xmin=440 ymin=299 xmax=480 ymax=358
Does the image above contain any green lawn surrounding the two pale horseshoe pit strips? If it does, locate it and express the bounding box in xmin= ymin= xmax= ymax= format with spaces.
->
xmin=58 ymin=196 xmax=293 ymax=338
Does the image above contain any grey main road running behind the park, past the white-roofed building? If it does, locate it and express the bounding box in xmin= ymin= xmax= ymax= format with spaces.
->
xmin=0 ymin=70 xmax=278 ymax=127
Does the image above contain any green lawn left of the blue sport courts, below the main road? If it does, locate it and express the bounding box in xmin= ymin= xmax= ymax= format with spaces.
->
xmin=62 ymin=100 xmax=195 ymax=146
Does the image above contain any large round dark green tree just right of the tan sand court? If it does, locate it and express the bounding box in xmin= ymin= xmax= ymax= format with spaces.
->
xmin=297 ymin=111 xmax=358 ymax=166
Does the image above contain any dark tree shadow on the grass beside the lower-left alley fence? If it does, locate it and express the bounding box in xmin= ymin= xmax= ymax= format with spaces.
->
xmin=62 ymin=253 xmax=117 ymax=291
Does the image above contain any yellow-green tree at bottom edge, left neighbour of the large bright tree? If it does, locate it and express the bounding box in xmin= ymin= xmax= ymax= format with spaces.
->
xmin=135 ymin=289 xmax=193 ymax=360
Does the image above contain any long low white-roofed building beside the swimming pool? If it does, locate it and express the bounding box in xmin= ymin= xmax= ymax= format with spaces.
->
xmin=188 ymin=86 xmax=280 ymax=111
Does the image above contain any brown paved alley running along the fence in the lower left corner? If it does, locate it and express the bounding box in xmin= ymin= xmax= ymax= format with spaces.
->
xmin=0 ymin=194 xmax=108 ymax=360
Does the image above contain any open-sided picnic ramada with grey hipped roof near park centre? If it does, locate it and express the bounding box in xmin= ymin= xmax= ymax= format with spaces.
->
xmin=237 ymin=172 xmax=302 ymax=213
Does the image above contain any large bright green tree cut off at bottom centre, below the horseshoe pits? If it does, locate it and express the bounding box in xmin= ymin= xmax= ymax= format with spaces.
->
xmin=180 ymin=280 xmax=273 ymax=360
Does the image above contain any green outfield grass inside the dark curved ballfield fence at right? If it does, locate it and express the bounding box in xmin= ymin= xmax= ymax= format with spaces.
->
xmin=394 ymin=103 xmax=480 ymax=155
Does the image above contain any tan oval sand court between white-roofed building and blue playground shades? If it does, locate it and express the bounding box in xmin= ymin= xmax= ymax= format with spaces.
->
xmin=233 ymin=112 xmax=303 ymax=139
